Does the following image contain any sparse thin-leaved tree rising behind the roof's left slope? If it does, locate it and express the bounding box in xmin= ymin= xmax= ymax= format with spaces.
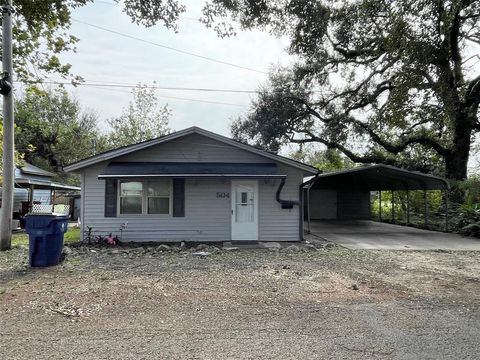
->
xmin=107 ymin=86 xmax=172 ymax=147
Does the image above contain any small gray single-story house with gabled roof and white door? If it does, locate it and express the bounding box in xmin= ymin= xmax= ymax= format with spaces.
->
xmin=65 ymin=127 xmax=318 ymax=242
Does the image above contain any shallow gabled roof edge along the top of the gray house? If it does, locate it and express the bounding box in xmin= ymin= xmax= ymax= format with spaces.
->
xmin=64 ymin=126 xmax=318 ymax=174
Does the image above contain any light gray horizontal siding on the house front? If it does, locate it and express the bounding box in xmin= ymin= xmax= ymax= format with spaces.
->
xmin=81 ymin=134 xmax=303 ymax=241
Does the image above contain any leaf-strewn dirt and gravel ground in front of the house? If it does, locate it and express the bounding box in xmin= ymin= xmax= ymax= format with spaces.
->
xmin=0 ymin=243 xmax=480 ymax=359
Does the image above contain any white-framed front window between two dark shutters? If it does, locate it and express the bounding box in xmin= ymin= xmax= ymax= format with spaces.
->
xmin=119 ymin=180 xmax=171 ymax=214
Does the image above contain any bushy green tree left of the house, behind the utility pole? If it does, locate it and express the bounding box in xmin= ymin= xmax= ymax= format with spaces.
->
xmin=15 ymin=87 xmax=105 ymax=183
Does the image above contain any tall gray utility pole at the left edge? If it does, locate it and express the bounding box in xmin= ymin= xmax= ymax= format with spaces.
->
xmin=0 ymin=0 xmax=15 ymax=250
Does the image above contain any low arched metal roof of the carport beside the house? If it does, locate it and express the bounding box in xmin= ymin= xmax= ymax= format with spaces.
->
xmin=311 ymin=164 xmax=449 ymax=191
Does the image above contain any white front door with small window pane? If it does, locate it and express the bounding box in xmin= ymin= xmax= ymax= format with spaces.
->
xmin=231 ymin=180 xmax=258 ymax=240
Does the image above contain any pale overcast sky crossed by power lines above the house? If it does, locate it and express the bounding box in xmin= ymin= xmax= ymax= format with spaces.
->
xmin=55 ymin=0 xmax=291 ymax=135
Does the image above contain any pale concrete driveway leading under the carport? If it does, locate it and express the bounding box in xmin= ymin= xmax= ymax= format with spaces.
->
xmin=305 ymin=220 xmax=480 ymax=250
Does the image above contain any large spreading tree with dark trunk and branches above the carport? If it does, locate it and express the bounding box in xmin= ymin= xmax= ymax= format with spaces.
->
xmin=204 ymin=0 xmax=480 ymax=179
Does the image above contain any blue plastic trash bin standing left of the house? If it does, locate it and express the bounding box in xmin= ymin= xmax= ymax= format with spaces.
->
xmin=25 ymin=214 xmax=68 ymax=267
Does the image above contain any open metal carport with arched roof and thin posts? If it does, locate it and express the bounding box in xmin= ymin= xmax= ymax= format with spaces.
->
xmin=304 ymin=164 xmax=449 ymax=240
